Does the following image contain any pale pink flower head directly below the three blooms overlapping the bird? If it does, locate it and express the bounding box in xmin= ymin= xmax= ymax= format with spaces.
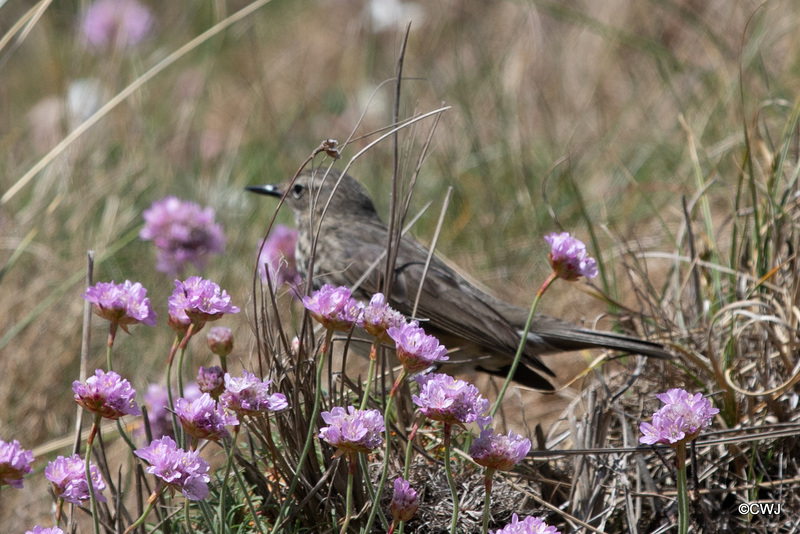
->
xmin=319 ymin=406 xmax=386 ymax=454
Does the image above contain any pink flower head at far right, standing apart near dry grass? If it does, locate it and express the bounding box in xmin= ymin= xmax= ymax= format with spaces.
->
xmin=639 ymin=388 xmax=719 ymax=445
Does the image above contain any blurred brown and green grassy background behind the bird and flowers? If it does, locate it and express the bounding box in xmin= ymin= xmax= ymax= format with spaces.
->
xmin=0 ymin=0 xmax=800 ymax=531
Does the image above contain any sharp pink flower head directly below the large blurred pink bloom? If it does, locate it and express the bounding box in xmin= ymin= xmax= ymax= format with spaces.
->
xmin=169 ymin=276 xmax=239 ymax=328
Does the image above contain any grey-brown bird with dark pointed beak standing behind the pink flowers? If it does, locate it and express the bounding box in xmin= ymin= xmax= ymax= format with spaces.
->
xmin=246 ymin=168 xmax=672 ymax=391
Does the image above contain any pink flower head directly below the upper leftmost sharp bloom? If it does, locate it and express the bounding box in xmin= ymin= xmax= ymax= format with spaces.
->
xmin=72 ymin=369 xmax=142 ymax=419
